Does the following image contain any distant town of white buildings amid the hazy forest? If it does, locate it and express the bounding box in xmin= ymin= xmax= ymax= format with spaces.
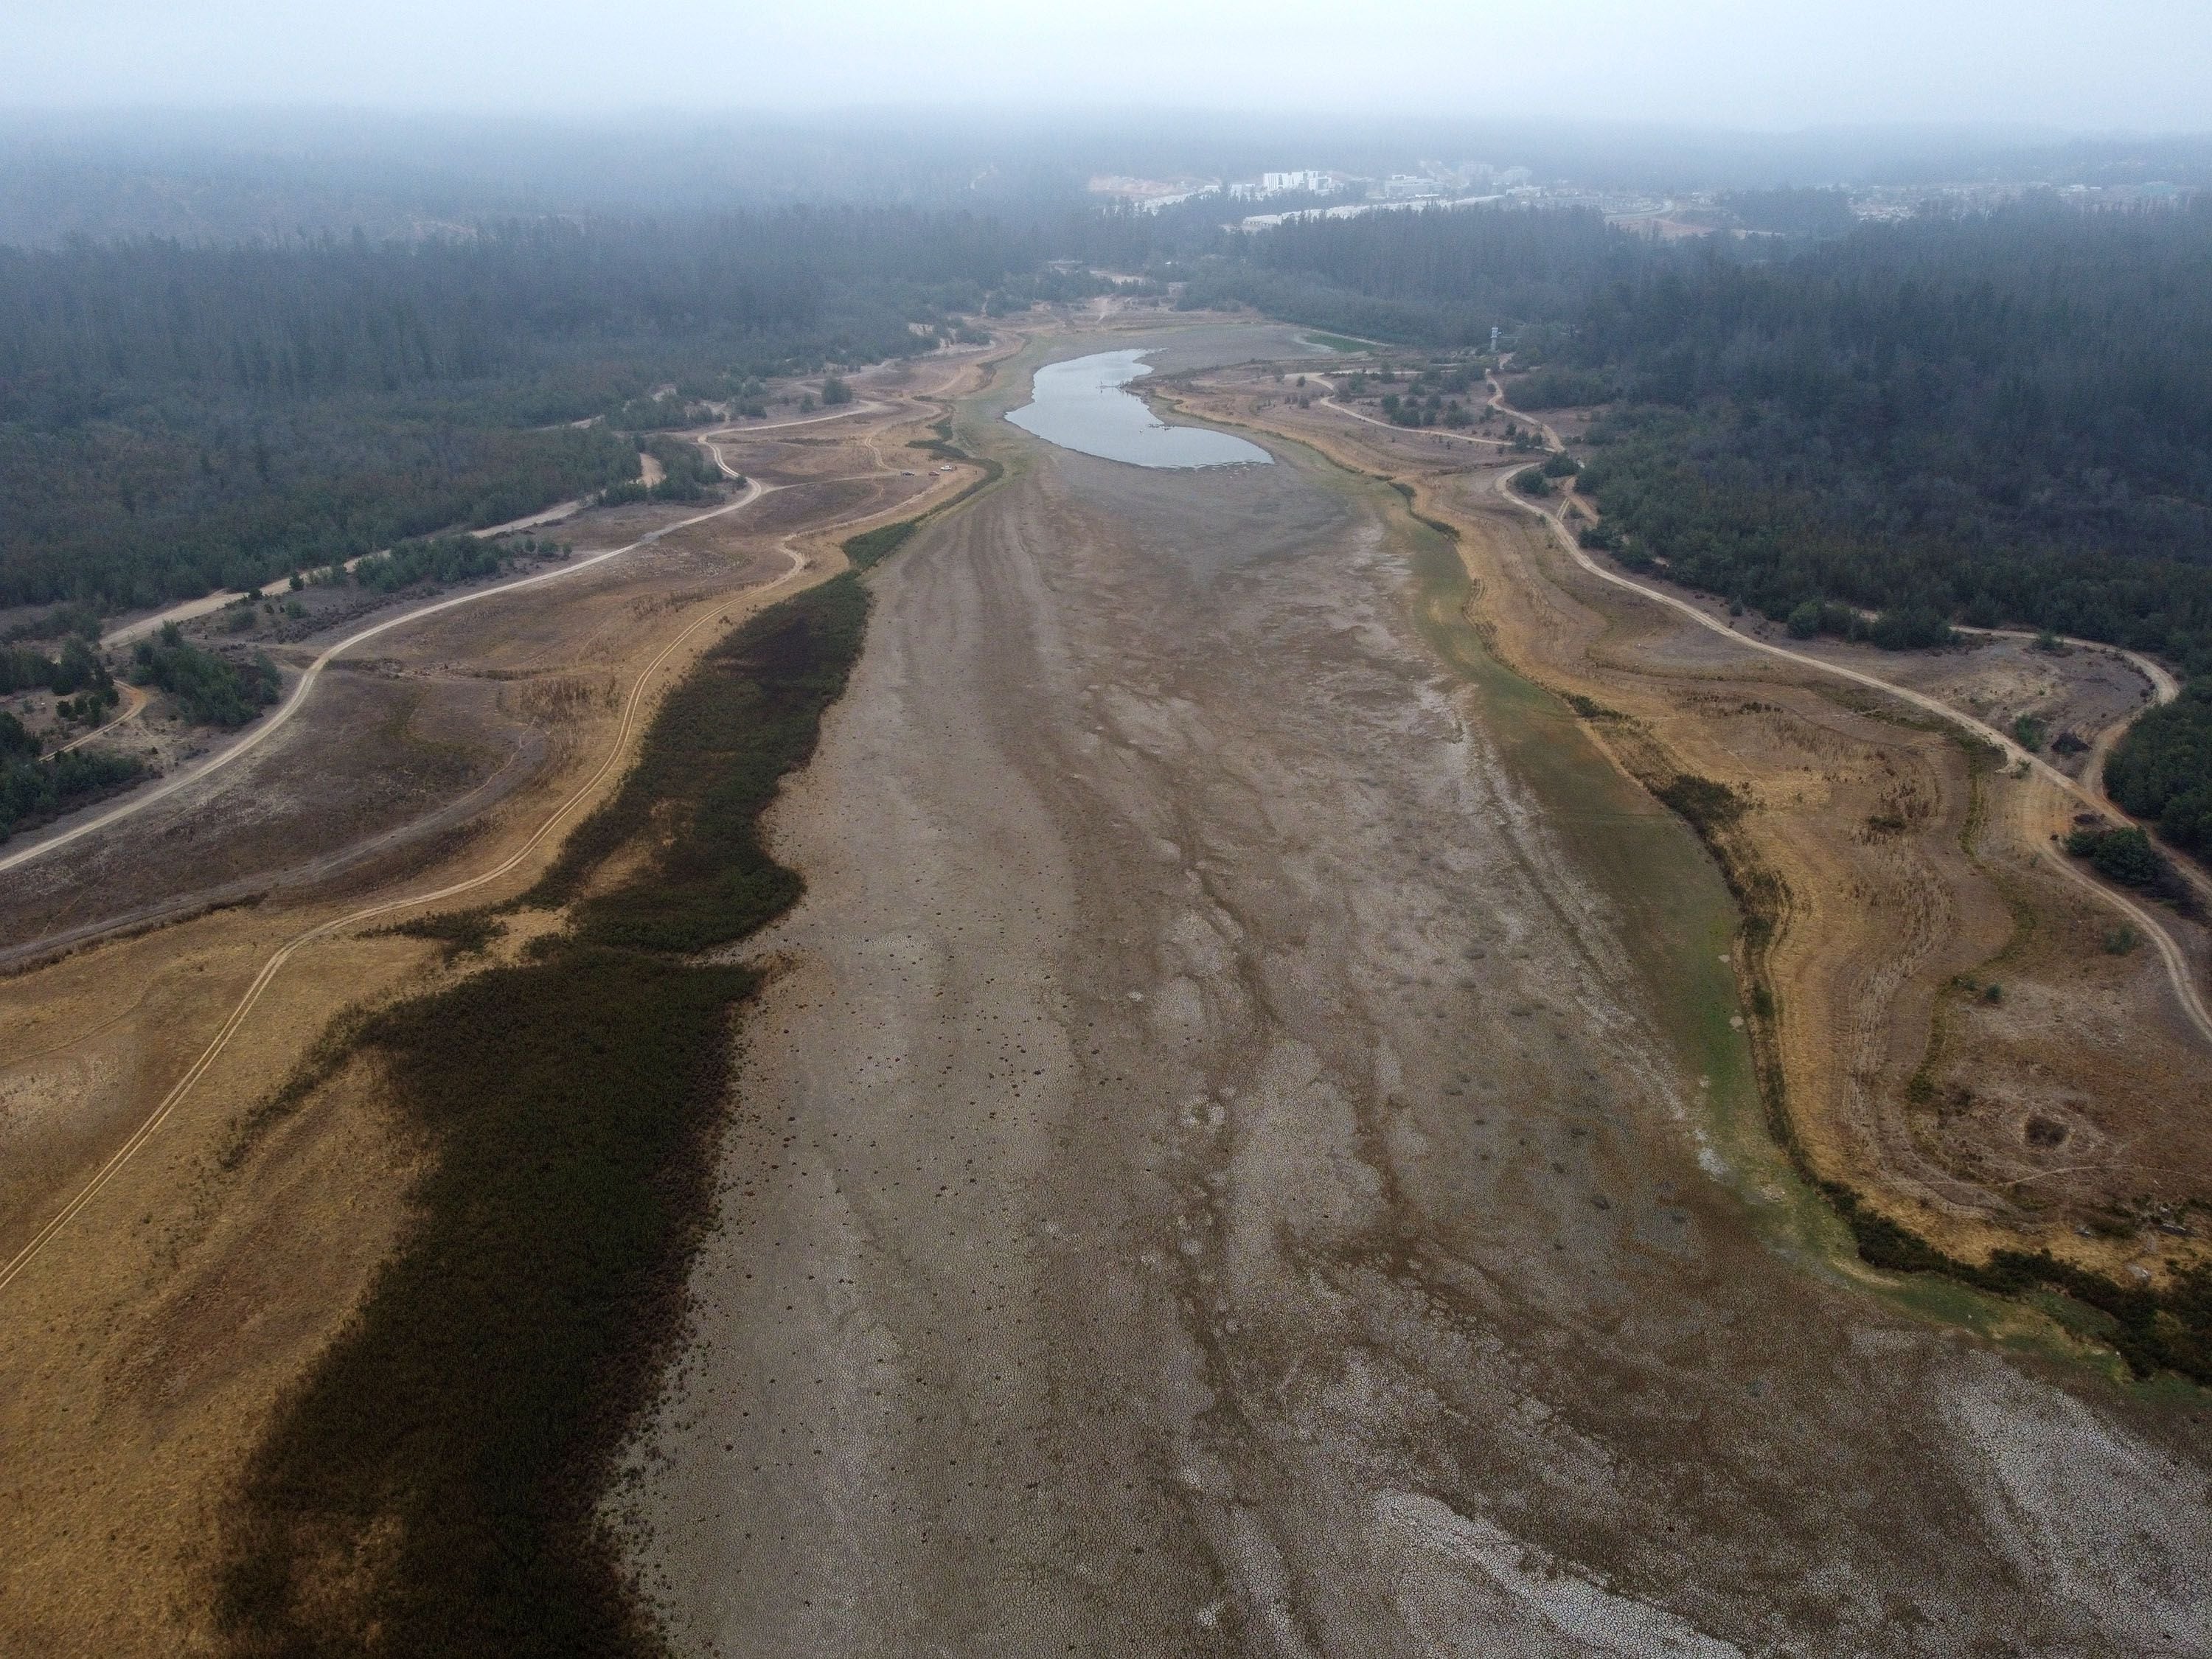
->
xmin=1088 ymin=161 xmax=2199 ymax=237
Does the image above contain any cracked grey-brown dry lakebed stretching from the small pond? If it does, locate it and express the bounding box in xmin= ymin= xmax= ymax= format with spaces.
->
xmin=626 ymin=327 xmax=2212 ymax=1655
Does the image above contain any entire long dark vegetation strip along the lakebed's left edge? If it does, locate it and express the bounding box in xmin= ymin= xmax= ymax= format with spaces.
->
xmin=219 ymin=575 xmax=867 ymax=1659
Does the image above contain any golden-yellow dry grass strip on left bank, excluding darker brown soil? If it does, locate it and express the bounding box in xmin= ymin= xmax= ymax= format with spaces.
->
xmin=0 ymin=345 xmax=1013 ymax=1655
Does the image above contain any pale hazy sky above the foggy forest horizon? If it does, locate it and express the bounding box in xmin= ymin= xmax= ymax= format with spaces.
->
xmin=13 ymin=0 xmax=2212 ymax=131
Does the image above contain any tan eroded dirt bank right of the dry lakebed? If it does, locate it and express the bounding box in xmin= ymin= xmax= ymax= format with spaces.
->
xmin=1192 ymin=363 xmax=2212 ymax=1283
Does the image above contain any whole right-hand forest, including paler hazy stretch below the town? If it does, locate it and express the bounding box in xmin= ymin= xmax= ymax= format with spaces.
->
xmin=1188 ymin=192 xmax=2212 ymax=845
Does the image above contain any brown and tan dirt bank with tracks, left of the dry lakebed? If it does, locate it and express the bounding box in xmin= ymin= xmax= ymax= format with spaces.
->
xmin=0 ymin=341 xmax=1013 ymax=1655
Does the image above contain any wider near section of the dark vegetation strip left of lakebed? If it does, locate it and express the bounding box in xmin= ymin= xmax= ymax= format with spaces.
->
xmin=219 ymin=947 xmax=752 ymax=1659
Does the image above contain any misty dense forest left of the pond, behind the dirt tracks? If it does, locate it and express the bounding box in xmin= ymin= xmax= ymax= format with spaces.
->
xmin=0 ymin=210 xmax=1037 ymax=611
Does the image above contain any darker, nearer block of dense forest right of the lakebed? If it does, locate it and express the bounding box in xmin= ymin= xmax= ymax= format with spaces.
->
xmin=1559 ymin=210 xmax=2212 ymax=668
